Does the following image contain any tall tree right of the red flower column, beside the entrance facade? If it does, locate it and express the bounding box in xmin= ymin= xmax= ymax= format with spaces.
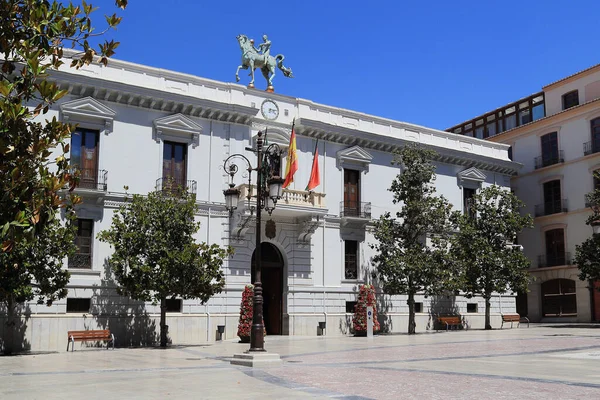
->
xmin=371 ymin=146 xmax=453 ymax=334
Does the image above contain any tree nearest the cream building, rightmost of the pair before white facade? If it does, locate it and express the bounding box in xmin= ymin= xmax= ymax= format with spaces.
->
xmin=451 ymin=185 xmax=533 ymax=329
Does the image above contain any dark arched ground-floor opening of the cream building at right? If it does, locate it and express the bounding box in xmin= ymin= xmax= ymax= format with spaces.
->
xmin=542 ymin=279 xmax=577 ymax=317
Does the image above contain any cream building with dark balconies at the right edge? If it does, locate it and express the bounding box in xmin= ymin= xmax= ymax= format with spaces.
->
xmin=448 ymin=65 xmax=600 ymax=322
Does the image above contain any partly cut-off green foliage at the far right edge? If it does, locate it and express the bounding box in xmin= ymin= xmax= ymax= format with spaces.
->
xmin=573 ymin=173 xmax=600 ymax=281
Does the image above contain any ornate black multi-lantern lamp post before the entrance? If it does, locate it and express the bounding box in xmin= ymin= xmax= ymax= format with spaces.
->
xmin=223 ymin=132 xmax=284 ymax=352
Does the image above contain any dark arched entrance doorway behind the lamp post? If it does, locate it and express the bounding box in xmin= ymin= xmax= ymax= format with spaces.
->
xmin=251 ymin=242 xmax=284 ymax=335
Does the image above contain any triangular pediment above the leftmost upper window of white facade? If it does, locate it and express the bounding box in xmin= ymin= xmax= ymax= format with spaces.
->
xmin=60 ymin=97 xmax=117 ymax=135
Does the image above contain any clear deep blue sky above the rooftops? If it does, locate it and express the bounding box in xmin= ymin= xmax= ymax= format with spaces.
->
xmin=92 ymin=0 xmax=600 ymax=129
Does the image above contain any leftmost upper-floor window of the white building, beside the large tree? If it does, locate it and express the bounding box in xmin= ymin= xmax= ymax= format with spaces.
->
xmin=71 ymin=128 xmax=99 ymax=189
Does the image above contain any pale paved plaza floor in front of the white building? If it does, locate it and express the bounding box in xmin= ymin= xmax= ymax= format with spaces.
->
xmin=0 ymin=324 xmax=600 ymax=400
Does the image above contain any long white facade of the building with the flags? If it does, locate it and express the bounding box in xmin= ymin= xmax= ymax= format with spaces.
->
xmin=2 ymin=54 xmax=518 ymax=350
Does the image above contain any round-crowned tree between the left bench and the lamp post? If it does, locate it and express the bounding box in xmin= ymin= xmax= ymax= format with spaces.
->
xmin=98 ymin=189 xmax=232 ymax=347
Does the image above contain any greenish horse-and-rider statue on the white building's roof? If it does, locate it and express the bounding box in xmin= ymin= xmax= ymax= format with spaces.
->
xmin=235 ymin=35 xmax=294 ymax=92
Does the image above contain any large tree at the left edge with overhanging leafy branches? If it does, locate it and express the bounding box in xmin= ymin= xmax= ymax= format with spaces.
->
xmin=0 ymin=0 xmax=127 ymax=353
